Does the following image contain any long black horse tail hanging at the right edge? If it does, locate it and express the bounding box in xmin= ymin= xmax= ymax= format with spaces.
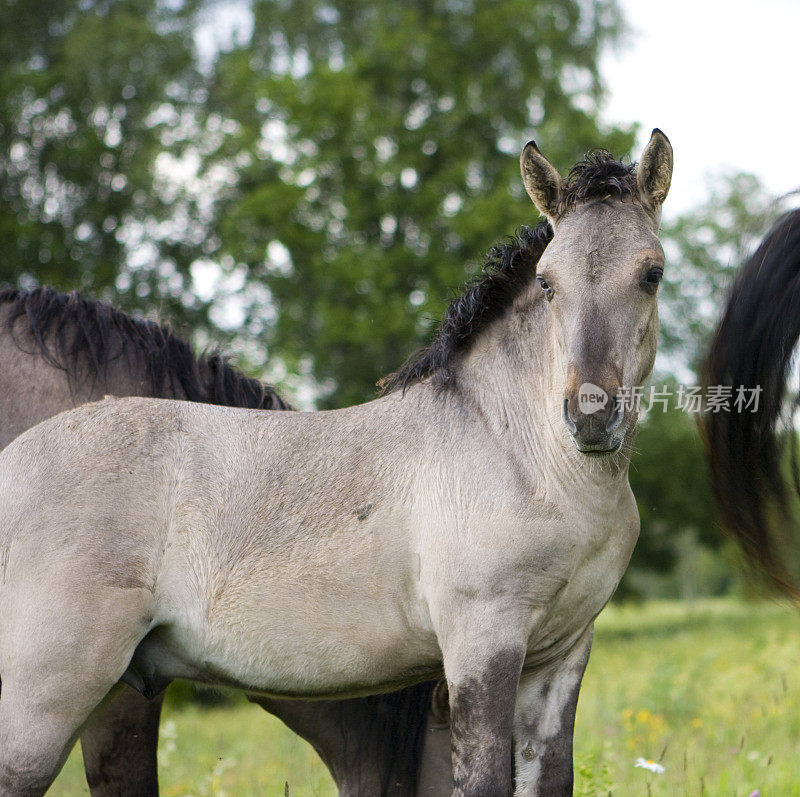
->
xmin=700 ymin=210 xmax=800 ymax=598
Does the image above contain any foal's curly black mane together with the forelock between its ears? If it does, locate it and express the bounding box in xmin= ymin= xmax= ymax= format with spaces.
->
xmin=378 ymin=150 xmax=638 ymax=394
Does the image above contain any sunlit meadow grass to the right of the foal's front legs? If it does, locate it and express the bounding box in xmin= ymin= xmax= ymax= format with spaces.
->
xmin=575 ymin=600 xmax=800 ymax=797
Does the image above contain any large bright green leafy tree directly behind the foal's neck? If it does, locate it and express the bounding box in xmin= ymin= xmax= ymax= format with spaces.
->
xmin=210 ymin=0 xmax=633 ymax=406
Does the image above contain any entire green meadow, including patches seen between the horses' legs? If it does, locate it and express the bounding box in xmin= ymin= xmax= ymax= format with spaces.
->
xmin=51 ymin=600 xmax=800 ymax=797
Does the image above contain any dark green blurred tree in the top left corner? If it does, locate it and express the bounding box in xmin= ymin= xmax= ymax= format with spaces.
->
xmin=0 ymin=0 xmax=205 ymax=324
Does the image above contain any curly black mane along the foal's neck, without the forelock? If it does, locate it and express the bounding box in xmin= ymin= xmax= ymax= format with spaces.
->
xmin=378 ymin=221 xmax=553 ymax=395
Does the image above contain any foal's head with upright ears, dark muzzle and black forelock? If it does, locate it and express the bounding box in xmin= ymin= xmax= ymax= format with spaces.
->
xmin=520 ymin=130 xmax=672 ymax=456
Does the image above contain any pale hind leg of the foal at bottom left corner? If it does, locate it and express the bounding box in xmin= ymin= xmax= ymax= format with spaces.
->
xmin=0 ymin=577 xmax=152 ymax=797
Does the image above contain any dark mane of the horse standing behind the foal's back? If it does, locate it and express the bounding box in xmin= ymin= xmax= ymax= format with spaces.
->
xmin=0 ymin=287 xmax=290 ymax=410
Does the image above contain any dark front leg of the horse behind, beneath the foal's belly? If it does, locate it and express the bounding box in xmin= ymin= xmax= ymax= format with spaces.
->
xmin=250 ymin=682 xmax=444 ymax=797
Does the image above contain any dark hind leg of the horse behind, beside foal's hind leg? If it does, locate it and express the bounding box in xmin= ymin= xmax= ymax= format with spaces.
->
xmin=81 ymin=686 xmax=165 ymax=797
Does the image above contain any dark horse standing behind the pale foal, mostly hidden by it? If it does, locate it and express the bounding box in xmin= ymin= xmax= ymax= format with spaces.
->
xmin=0 ymin=288 xmax=450 ymax=797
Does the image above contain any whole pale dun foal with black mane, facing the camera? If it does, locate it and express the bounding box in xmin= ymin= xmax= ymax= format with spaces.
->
xmin=0 ymin=131 xmax=672 ymax=795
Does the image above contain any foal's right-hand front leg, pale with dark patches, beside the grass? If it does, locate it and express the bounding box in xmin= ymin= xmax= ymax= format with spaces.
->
xmin=514 ymin=626 xmax=593 ymax=797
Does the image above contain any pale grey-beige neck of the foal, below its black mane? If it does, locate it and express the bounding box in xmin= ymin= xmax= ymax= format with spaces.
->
xmin=459 ymin=298 xmax=635 ymax=494
